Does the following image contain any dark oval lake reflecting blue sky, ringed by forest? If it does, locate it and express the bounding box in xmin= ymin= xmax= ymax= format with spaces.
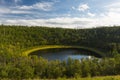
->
xmin=29 ymin=48 xmax=96 ymax=61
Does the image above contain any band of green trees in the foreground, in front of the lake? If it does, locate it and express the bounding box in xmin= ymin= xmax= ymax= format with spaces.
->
xmin=0 ymin=53 xmax=120 ymax=80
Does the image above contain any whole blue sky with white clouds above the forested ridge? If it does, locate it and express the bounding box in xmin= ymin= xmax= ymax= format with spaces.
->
xmin=0 ymin=0 xmax=120 ymax=28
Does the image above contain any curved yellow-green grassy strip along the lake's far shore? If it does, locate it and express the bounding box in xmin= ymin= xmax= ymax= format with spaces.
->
xmin=22 ymin=45 xmax=104 ymax=57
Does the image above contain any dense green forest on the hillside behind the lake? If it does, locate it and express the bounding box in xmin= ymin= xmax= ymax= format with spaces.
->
xmin=0 ymin=25 xmax=120 ymax=57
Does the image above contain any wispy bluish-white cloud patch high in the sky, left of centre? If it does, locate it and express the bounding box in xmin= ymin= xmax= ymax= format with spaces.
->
xmin=18 ymin=2 xmax=54 ymax=11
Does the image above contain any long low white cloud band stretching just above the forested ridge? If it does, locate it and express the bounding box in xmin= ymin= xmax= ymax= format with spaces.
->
xmin=1 ymin=12 xmax=120 ymax=28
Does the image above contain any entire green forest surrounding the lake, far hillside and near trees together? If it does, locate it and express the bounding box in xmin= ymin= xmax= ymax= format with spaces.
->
xmin=0 ymin=25 xmax=120 ymax=79
